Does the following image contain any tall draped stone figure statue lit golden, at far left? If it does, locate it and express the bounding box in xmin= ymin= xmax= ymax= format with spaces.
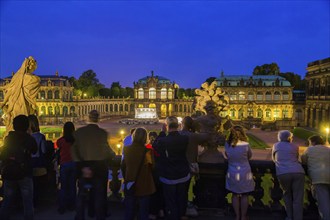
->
xmin=1 ymin=56 xmax=40 ymax=136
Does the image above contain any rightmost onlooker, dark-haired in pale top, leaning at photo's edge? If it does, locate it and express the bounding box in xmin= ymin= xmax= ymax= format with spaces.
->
xmin=301 ymin=135 xmax=330 ymax=220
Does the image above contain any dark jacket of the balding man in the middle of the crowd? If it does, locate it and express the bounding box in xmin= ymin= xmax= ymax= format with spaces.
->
xmin=153 ymin=131 xmax=190 ymax=180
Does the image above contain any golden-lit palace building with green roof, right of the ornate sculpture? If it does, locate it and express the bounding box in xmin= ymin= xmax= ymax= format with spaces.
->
xmin=217 ymin=75 xmax=303 ymax=127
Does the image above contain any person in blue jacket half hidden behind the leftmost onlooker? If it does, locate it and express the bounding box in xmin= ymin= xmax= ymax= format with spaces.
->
xmin=28 ymin=115 xmax=48 ymax=206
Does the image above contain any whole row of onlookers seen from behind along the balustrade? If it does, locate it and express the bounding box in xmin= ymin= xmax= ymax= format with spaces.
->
xmin=0 ymin=110 xmax=330 ymax=220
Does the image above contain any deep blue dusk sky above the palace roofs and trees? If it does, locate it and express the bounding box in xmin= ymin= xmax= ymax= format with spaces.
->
xmin=0 ymin=0 xmax=330 ymax=88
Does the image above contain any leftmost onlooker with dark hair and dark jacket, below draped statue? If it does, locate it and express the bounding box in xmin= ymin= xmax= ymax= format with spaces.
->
xmin=0 ymin=115 xmax=38 ymax=220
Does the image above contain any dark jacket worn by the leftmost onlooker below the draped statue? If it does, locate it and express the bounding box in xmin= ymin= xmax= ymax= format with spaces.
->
xmin=0 ymin=131 xmax=38 ymax=176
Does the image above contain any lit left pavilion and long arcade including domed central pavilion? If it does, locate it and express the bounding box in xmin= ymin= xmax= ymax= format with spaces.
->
xmin=0 ymin=73 xmax=193 ymax=124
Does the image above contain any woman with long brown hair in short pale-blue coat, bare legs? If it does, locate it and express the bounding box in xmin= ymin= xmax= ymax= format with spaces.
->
xmin=225 ymin=126 xmax=255 ymax=220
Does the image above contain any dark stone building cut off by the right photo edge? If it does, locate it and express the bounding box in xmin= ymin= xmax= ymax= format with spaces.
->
xmin=305 ymin=58 xmax=330 ymax=129
